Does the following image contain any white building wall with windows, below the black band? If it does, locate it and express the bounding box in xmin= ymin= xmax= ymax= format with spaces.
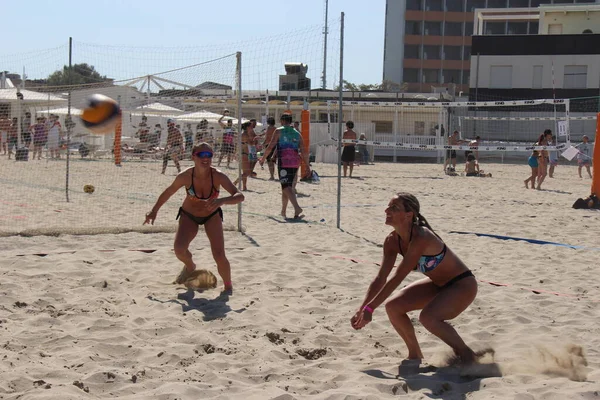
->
xmin=470 ymin=55 xmax=600 ymax=89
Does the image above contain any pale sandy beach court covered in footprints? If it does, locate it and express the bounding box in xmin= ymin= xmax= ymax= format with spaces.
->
xmin=0 ymin=157 xmax=600 ymax=400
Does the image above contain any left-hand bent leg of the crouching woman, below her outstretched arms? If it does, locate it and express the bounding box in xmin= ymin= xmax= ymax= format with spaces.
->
xmin=385 ymin=278 xmax=440 ymax=359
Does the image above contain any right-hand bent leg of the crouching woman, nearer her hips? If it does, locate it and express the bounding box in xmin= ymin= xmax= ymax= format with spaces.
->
xmin=419 ymin=277 xmax=477 ymax=363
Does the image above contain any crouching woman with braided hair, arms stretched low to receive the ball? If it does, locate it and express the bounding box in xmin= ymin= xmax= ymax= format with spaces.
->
xmin=351 ymin=193 xmax=478 ymax=364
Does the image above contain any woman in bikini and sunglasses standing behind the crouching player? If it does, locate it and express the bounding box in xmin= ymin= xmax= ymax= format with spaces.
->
xmin=144 ymin=143 xmax=244 ymax=290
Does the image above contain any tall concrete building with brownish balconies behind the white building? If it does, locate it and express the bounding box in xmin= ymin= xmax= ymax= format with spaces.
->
xmin=383 ymin=0 xmax=599 ymax=95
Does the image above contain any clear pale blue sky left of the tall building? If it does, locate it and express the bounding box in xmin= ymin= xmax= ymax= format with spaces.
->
xmin=0 ymin=0 xmax=385 ymax=89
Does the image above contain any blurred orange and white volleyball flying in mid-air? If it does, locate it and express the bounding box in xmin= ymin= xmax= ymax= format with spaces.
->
xmin=81 ymin=94 xmax=121 ymax=134
